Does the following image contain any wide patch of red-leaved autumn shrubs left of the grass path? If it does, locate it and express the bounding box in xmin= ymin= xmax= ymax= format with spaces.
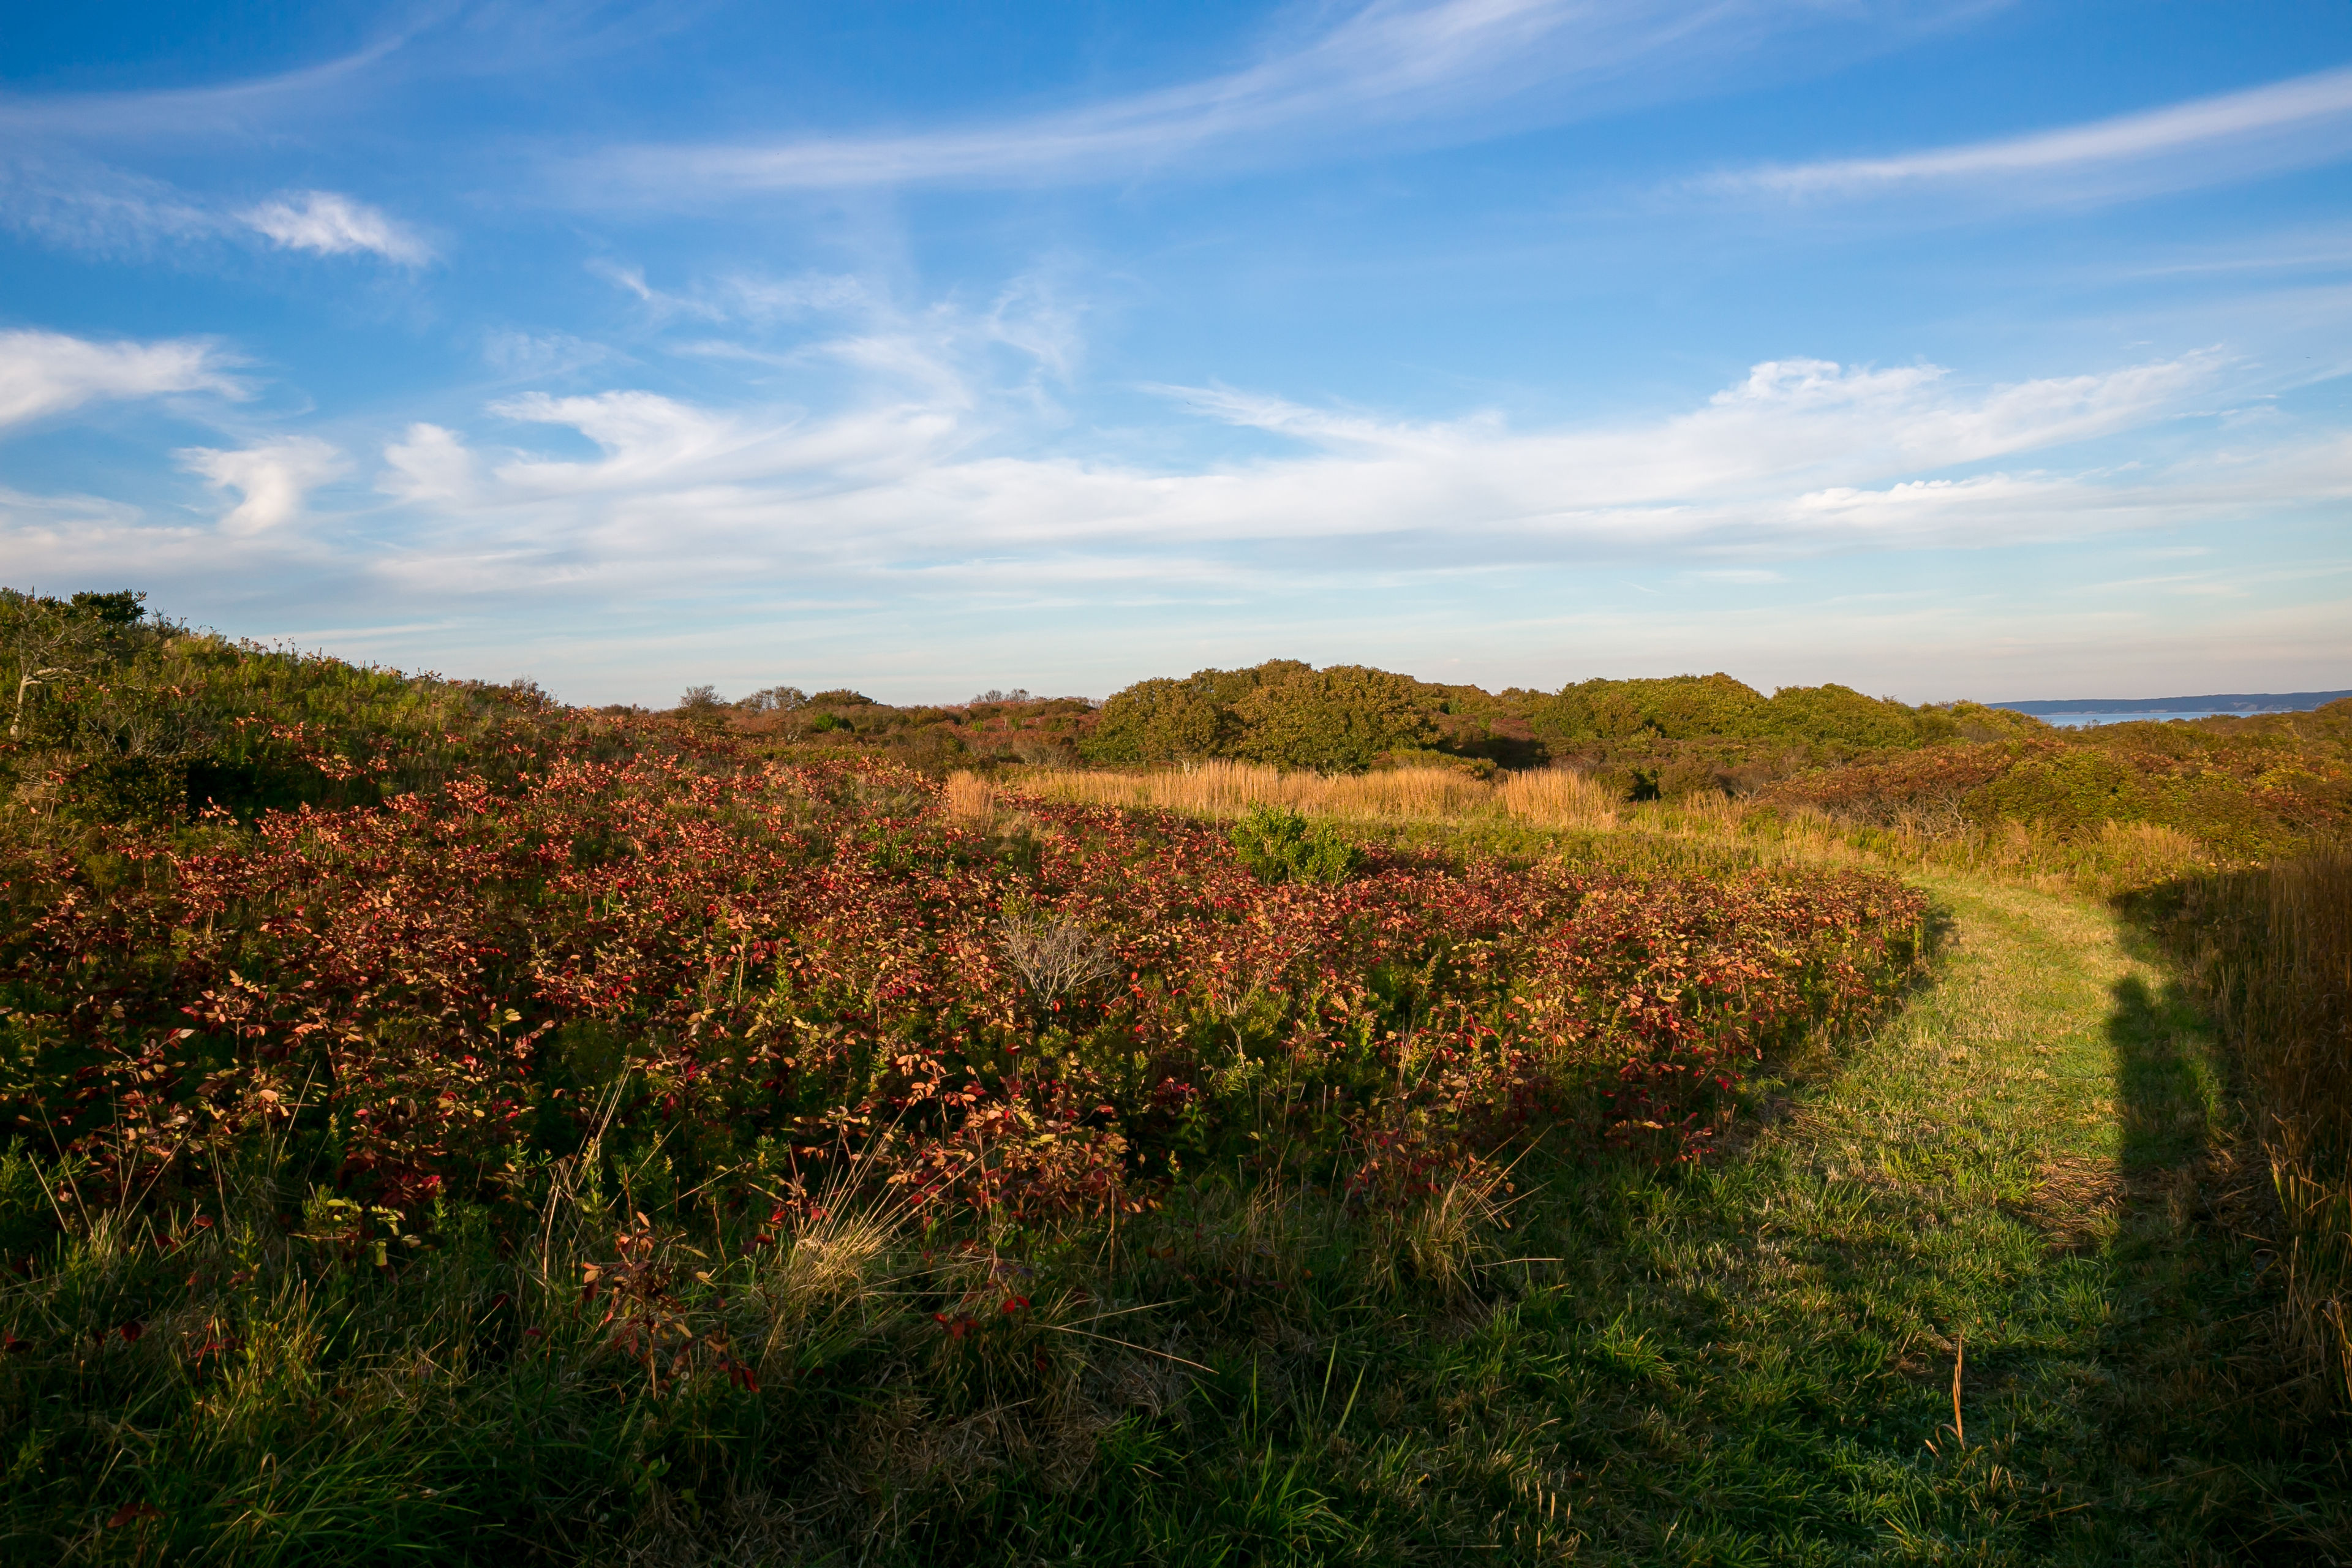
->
xmin=0 ymin=743 xmax=1921 ymax=1246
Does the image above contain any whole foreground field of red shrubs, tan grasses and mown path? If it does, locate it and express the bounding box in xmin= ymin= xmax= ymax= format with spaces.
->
xmin=0 ymin=600 xmax=2352 ymax=1566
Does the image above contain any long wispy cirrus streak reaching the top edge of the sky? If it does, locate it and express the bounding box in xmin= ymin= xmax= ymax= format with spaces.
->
xmin=571 ymin=0 xmax=1973 ymax=202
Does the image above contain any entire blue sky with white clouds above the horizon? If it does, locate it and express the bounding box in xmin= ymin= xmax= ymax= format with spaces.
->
xmin=0 ymin=0 xmax=2352 ymax=703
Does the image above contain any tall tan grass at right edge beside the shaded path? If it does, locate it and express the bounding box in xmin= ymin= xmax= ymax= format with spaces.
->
xmin=2173 ymin=849 xmax=2352 ymax=1413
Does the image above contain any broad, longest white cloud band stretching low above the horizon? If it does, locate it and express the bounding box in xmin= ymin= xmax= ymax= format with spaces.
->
xmin=336 ymin=355 xmax=2314 ymax=597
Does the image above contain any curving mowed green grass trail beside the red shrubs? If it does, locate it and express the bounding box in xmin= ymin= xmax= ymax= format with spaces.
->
xmin=1533 ymin=875 xmax=2296 ymax=1563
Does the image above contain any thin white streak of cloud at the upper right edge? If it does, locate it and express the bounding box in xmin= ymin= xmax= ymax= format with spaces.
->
xmin=1705 ymin=68 xmax=2352 ymax=200
